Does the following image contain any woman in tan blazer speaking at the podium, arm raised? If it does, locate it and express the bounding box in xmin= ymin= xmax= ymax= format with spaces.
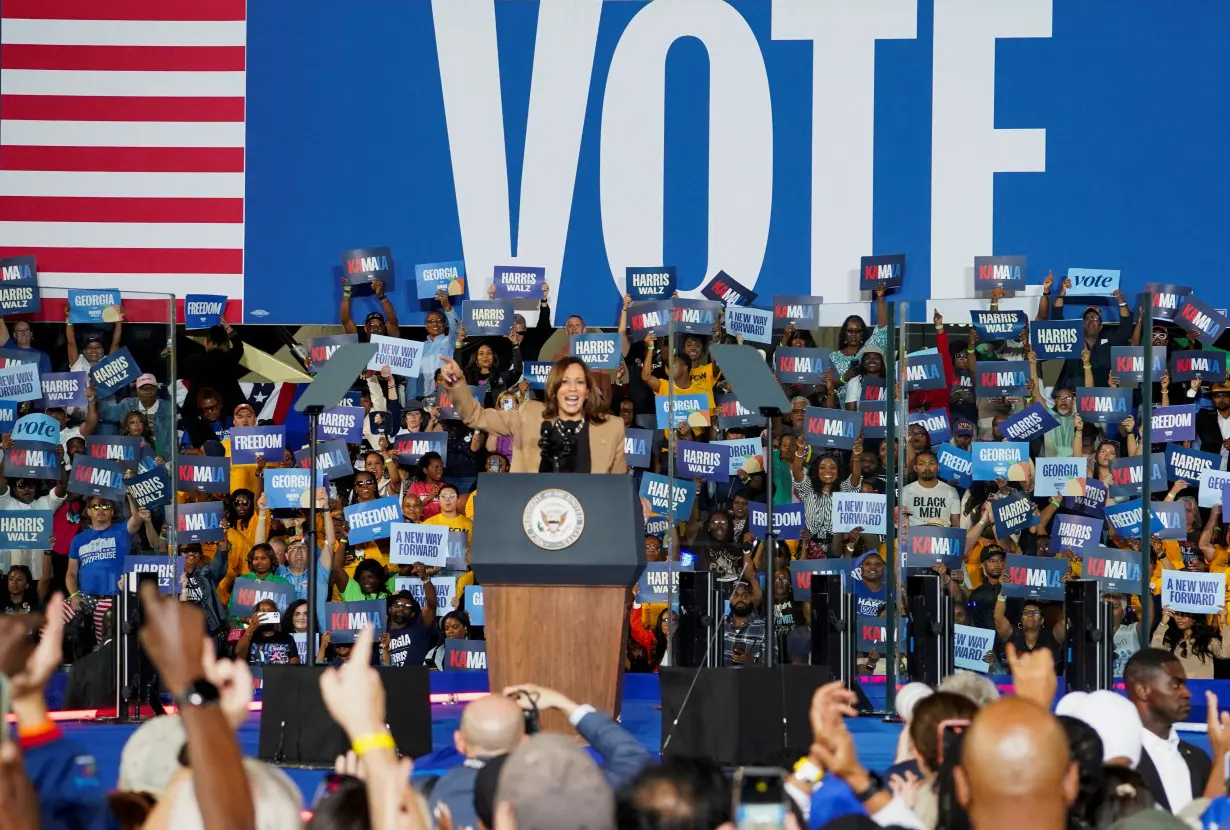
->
xmin=440 ymin=357 xmax=627 ymax=473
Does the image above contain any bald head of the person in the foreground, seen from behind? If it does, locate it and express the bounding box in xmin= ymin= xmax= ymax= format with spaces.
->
xmin=953 ymin=697 xmax=1077 ymax=830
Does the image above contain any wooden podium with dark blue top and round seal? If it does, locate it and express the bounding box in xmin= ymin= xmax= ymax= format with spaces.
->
xmin=470 ymin=473 xmax=645 ymax=734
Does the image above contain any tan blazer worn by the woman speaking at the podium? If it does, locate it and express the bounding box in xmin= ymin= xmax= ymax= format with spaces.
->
xmin=449 ymin=384 xmax=627 ymax=473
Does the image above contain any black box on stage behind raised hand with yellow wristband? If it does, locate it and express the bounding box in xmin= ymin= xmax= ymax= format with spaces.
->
xmin=257 ymin=665 xmax=432 ymax=767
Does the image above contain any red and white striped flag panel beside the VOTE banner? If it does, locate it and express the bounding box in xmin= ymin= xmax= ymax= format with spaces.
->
xmin=0 ymin=0 xmax=247 ymax=320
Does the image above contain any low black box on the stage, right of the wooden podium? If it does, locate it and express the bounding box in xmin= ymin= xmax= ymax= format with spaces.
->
xmin=658 ymin=665 xmax=833 ymax=766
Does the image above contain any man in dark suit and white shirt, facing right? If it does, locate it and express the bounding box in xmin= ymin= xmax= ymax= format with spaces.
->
xmin=1123 ymin=648 xmax=1213 ymax=813
